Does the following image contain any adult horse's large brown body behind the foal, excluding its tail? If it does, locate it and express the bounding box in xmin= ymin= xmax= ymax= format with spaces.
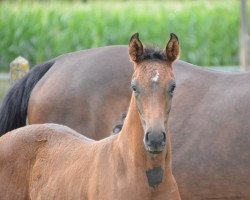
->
xmin=28 ymin=46 xmax=250 ymax=200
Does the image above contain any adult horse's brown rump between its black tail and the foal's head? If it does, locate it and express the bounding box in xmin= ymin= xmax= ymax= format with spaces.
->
xmin=28 ymin=46 xmax=132 ymax=140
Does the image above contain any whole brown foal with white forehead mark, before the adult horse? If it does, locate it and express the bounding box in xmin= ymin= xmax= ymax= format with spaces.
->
xmin=0 ymin=34 xmax=180 ymax=200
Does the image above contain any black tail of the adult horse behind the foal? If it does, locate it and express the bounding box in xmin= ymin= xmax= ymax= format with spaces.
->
xmin=0 ymin=60 xmax=55 ymax=136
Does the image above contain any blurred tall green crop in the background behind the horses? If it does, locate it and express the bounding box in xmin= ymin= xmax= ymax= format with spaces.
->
xmin=0 ymin=0 xmax=247 ymax=69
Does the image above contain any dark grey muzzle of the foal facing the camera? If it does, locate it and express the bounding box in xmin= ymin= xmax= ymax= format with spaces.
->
xmin=144 ymin=131 xmax=166 ymax=154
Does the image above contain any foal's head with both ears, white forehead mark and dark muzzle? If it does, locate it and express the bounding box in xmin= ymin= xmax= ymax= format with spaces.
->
xmin=129 ymin=33 xmax=179 ymax=154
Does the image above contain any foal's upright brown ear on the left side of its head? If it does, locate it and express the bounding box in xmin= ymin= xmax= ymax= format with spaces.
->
xmin=128 ymin=33 xmax=143 ymax=62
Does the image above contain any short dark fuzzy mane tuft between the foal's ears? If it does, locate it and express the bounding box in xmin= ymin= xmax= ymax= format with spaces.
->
xmin=141 ymin=46 xmax=167 ymax=61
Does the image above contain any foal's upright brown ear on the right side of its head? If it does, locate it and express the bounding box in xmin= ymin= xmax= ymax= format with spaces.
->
xmin=163 ymin=33 xmax=180 ymax=62
